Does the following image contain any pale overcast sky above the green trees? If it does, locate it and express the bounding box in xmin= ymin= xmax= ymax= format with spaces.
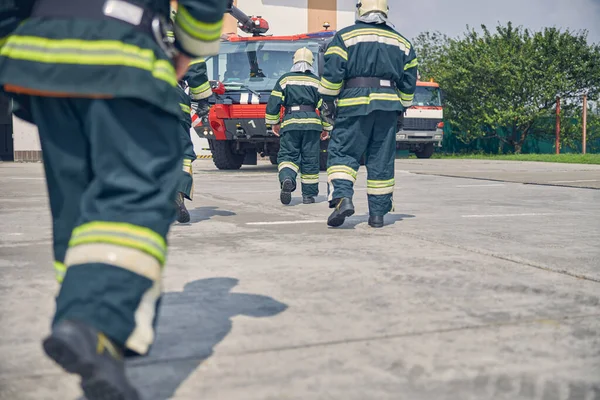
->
xmin=389 ymin=0 xmax=600 ymax=43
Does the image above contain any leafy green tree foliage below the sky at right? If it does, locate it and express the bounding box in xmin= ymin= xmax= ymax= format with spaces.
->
xmin=414 ymin=23 xmax=600 ymax=153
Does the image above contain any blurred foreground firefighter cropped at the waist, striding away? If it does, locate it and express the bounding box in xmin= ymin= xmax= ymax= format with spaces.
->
xmin=0 ymin=0 xmax=226 ymax=400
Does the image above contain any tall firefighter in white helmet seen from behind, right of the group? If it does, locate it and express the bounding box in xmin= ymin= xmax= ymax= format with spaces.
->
xmin=319 ymin=0 xmax=417 ymax=228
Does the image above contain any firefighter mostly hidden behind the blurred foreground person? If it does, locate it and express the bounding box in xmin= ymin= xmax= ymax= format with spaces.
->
xmin=175 ymin=58 xmax=212 ymax=223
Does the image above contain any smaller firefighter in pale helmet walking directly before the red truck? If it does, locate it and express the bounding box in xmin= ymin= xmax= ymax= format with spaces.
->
xmin=266 ymin=47 xmax=332 ymax=205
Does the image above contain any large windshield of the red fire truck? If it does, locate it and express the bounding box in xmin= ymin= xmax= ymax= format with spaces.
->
xmin=206 ymin=40 xmax=319 ymax=92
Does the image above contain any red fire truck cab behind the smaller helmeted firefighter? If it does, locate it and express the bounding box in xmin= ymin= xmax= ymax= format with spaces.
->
xmin=196 ymin=31 xmax=335 ymax=169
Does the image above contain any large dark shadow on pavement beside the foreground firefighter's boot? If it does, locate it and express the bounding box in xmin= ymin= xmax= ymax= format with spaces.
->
xmin=127 ymin=278 xmax=287 ymax=400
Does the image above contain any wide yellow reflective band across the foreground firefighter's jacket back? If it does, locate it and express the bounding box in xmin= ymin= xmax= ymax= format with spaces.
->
xmin=0 ymin=35 xmax=177 ymax=86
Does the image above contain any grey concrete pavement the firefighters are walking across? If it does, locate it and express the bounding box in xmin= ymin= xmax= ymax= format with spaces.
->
xmin=0 ymin=160 xmax=600 ymax=400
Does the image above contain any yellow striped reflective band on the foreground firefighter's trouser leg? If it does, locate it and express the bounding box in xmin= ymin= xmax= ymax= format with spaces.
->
xmin=69 ymin=221 xmax=167 ymax=264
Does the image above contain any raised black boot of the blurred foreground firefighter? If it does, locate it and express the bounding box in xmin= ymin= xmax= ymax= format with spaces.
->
xmin=43 ymin=321 xmax=140 ymax=400
